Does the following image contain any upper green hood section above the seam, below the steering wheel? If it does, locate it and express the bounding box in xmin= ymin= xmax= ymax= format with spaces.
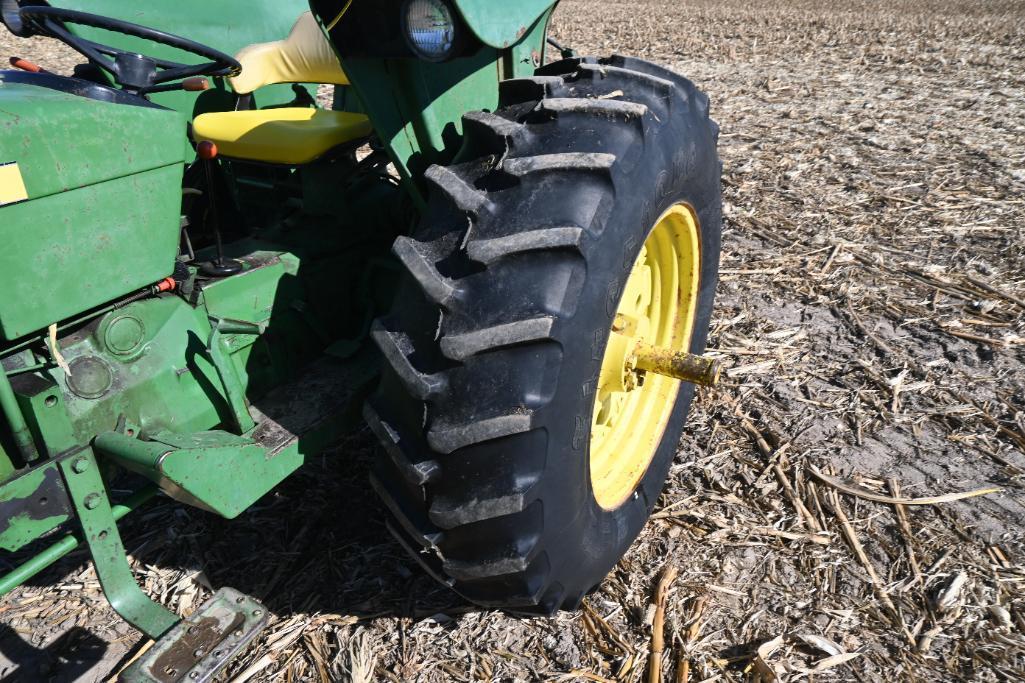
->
xmin=0 ymin=72 xmax=186 ymax=199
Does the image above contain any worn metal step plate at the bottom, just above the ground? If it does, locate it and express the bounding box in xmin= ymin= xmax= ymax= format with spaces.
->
xmin=120 ymin=588 xmax=268 ymax=683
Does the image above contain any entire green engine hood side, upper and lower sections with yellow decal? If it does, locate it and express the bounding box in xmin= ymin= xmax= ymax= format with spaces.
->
xmin=0 ymin=81 xmax=186 ymax=339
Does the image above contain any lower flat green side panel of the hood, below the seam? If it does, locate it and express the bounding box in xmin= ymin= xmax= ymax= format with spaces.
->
xmin=0 ymin=161 xmax=182 ymax=339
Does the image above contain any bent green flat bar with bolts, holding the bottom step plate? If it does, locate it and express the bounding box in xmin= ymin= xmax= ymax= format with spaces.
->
xmin=60 ymin=447 xmax=179 ymax=639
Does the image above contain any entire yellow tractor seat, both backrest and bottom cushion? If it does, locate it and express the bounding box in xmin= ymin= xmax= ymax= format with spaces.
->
xmin=193 ymin=11 xmax=371 ymax=165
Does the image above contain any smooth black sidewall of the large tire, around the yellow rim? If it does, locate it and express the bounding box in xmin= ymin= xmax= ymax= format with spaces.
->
xmin=538 ymin=109 xmax=722 ymax=595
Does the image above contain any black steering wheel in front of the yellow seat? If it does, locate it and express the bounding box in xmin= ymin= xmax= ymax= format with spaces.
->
xmin=19 ymin=5 xmax=242 ymax=93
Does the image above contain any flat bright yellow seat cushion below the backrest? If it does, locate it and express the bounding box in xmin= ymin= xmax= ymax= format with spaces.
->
xmin=193 ymin=107 xmax=371 ymax=166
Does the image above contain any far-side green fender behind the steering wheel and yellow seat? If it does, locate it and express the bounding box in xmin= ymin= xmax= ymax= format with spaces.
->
xmin=56 ymin=0 xmax=310 ymax=118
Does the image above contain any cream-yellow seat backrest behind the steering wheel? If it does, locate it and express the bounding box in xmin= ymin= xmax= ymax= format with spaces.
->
xmin=229 ymin=11 xmax=349 ymax=94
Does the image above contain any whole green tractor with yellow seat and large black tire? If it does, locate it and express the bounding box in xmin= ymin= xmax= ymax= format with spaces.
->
xmin=0 ymin=0 xmax=722 ymax=682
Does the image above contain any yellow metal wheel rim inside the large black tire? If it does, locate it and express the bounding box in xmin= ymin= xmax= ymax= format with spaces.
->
xmin=589 ymin=204 xmax=701 ymax=510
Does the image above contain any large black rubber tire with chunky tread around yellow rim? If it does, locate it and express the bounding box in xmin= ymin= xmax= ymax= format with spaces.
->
xmin=365 ymin=56 xmax=722 ymax=613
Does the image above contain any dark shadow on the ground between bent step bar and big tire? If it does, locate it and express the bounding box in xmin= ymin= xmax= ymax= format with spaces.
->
xmin=173 ymin=428 xmax=467 ymax=618
